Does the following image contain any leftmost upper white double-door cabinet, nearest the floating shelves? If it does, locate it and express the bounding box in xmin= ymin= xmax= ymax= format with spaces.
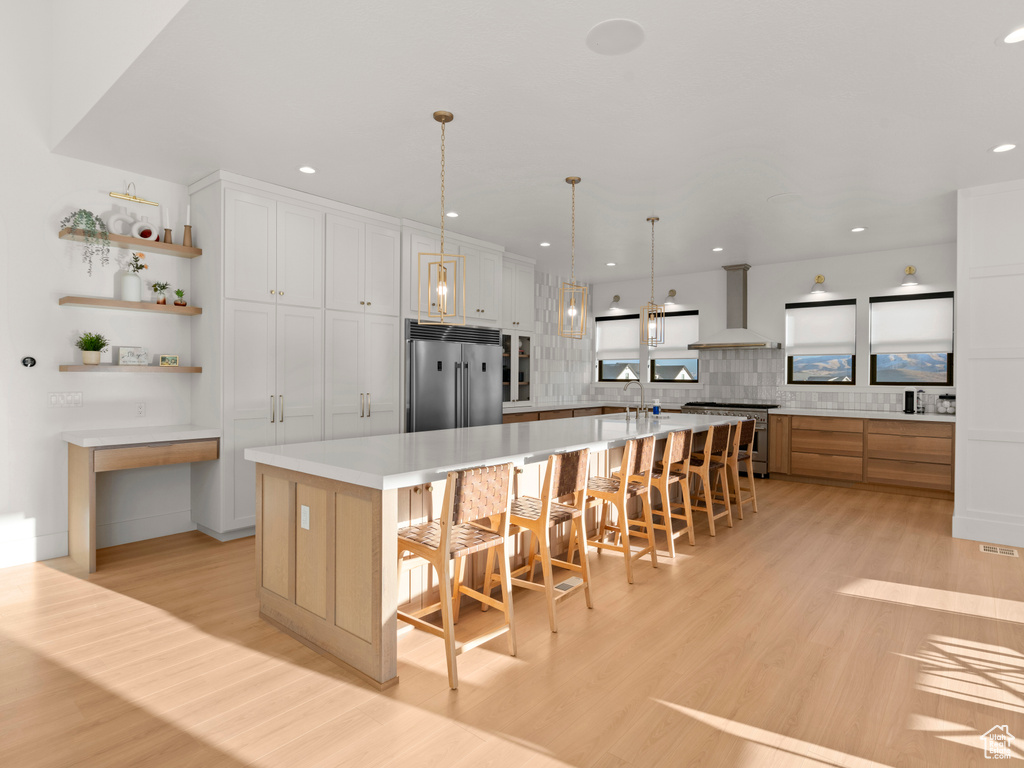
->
xmin=224 ymin=188 xmax=324 ymax=307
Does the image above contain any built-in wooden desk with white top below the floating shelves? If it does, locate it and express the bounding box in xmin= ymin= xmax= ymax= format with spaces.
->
xmin=60 ymin=424 xmax=220 ymax=573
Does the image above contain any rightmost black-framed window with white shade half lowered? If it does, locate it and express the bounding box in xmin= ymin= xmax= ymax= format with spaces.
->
xmin=869 ymin=291 xmax=953 ymax=386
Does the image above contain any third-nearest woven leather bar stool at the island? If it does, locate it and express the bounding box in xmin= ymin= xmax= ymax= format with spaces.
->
xmin=585 ymin=435 xmax=657 ymax=584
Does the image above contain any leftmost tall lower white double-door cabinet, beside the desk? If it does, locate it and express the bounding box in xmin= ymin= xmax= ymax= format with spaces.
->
xmin=221 ymin=301 xmax=324 ymax=528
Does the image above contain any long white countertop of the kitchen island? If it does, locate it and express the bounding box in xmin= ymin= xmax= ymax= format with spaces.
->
xmin=245 ymin=414 xmax=729 ymax=490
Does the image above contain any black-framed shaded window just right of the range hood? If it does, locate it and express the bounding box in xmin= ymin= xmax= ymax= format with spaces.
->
xmin=785 ymin=299 xmax=857 ymax=385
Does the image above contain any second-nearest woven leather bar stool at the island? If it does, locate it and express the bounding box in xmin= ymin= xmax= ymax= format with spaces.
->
xmin=483 ymin=449 xmax=594 ymax=632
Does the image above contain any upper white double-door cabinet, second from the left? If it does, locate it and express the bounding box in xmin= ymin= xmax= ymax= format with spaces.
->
xmin=325 ymin=213 xmax=401 ymax=316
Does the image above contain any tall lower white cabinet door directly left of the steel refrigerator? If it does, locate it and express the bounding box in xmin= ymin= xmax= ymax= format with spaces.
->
xmin=361 ymin=315 xmax=402 ymax=434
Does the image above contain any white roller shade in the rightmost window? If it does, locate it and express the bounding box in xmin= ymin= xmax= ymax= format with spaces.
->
xmin=870 ymin=293 xmax=953 ymax=354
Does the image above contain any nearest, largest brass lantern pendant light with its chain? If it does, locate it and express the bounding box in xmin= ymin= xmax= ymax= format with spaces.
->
xmin=417 ymin=112 xmax=466 ymax=326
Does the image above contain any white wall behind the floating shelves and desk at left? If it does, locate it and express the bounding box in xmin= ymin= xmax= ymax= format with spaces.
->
xmin=0 ymin=3 xmax=190 ymax=566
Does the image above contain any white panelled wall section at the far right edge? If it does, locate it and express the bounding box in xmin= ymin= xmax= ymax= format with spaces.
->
xmin=953 ymin=180 xmax=1024 ymax=547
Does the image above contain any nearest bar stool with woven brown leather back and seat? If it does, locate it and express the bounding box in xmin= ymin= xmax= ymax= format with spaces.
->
xmin=398 ymin=464 xmax=516 ymax=690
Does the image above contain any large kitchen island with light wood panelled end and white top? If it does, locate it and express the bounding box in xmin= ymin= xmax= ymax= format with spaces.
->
xmin=245 ymin=414 xmax=728 ymax=688
